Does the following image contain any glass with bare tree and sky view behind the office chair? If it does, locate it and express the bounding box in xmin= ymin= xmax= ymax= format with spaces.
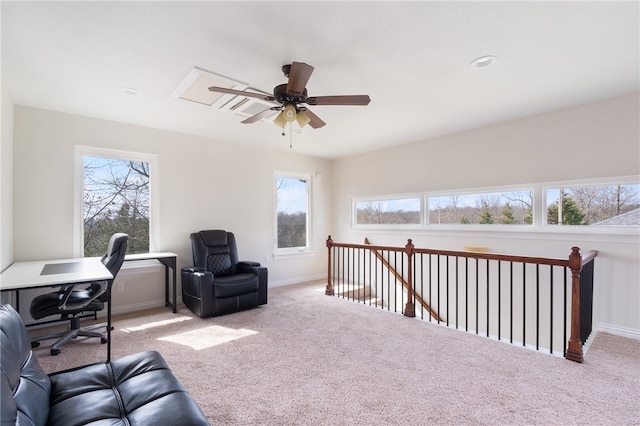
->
xmin=83 ymin=156 xmax=150 ymax=256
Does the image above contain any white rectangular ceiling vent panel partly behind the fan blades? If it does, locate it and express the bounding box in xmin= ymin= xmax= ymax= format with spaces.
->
xmin=171 ymin=67 xmax=277 ymax=122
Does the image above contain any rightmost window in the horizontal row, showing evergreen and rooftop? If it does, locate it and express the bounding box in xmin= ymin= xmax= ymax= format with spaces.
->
xmin=546 ymin=184 xmax=640 ymax=226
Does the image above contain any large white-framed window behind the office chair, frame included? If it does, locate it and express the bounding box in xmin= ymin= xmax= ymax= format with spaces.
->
xmin=76 ymin=147 xmax=155 ymax=257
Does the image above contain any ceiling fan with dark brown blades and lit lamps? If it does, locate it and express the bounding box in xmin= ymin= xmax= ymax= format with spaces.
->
xmin=209 ymin=62 xmax=371 ymax=129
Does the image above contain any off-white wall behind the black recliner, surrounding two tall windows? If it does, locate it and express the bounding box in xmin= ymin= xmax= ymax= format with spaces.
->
xmin=13 ymin=105 xmax=331 ymax=312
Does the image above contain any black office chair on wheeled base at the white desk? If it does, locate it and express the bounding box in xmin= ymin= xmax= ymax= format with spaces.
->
xmin=30 ymin=233 xmax=129 ymax=355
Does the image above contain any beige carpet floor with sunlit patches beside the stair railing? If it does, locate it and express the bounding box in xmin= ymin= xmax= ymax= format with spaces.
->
xmin=33 ymin=283 xmax=640 ymax=425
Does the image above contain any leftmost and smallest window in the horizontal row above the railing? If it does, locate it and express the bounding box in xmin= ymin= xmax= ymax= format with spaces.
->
xmin=355 ymin=197 xmax=422 ymax=225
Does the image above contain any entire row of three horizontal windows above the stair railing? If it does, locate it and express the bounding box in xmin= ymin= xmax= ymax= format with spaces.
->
xmin=352 ymin=176 xmax=640 ymax=234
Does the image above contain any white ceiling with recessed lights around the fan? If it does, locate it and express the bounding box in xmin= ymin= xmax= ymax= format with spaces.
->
xmin=2 ymin=1 xmax=640 ymax=158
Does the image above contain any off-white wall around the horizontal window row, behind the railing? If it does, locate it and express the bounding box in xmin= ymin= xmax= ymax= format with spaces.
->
xmin=332 ymin=94 xmax=640 ymax=338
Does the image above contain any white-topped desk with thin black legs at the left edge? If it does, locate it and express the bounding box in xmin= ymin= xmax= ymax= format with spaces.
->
xmin=0 ymin=257 xmax=113 ymax=361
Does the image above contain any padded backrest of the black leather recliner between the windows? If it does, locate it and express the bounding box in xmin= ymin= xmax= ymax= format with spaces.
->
xmin=191 ymin=229 xmax=238 ymax=277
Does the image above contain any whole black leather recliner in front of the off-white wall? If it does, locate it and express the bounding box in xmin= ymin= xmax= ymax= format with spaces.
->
xmin=181 ymin=230 xmax=267 ymax=318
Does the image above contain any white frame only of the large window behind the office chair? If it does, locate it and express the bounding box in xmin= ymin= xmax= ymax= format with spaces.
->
xmin=73 ymin=145 xmax=160 ymax=257
